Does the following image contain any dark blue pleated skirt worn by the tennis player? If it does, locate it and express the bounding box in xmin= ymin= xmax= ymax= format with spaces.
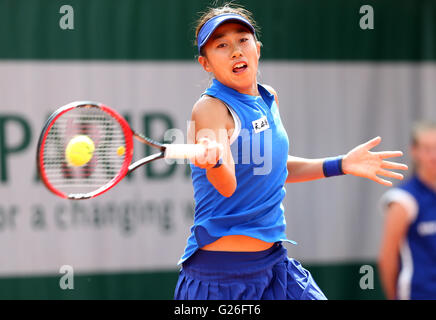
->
xmin=174 ymin=242 xmax=326 ymax=300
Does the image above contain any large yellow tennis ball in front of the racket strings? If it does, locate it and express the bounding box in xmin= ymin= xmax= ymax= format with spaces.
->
xmin=65 ymin=135 xmax=95 ymax=167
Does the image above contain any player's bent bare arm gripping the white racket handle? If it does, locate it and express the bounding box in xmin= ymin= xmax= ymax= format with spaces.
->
xmin=188 ymin=96 xmax=236 ymax=197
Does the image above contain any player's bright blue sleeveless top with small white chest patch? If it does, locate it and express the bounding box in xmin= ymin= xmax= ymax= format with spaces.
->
xmin=179 ymin=79 xmax=295 ymax=264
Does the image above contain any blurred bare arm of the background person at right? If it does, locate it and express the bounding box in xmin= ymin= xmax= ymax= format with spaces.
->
xmin=378 ymin=202 xmax=410 ymax=300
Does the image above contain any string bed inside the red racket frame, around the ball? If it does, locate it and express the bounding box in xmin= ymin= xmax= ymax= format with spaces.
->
xmin=43 ymin=107 xmax=126 ymax=194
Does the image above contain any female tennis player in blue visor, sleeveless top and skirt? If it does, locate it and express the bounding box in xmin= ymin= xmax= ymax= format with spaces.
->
xmin=175 ymin=5 xmax=407 ymax=300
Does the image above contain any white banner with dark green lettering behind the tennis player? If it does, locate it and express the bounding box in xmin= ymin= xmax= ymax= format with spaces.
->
xmin=0 ymin=61 xmax=436 ymax=276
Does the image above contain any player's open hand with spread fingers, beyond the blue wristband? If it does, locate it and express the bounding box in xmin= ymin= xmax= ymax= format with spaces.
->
xmin=342 ymin=137 xmax=408 ymax=186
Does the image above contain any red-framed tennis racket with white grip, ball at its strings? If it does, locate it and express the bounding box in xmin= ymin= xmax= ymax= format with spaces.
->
xmin=37 ymin=101 xmax=221 ymax=200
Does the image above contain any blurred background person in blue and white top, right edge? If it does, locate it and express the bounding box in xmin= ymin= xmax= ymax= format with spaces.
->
xmin=378 ymin=122 xmax=436 ymax=300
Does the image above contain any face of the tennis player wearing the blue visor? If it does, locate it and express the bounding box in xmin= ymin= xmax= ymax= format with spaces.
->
xmin=198 ymin=23 xmax=260 ymax=95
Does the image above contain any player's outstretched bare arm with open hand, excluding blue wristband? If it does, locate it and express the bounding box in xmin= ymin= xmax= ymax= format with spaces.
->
xmin=264 ymin=85 xmax=408 ymax=186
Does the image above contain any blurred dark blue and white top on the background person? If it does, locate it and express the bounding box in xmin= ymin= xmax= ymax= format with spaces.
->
xmin=398 ymin=176 xmax=436 ymax=299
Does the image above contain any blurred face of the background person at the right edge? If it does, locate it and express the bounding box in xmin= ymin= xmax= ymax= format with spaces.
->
xmin=412 ymin=129 xmax=436 ymax=177
